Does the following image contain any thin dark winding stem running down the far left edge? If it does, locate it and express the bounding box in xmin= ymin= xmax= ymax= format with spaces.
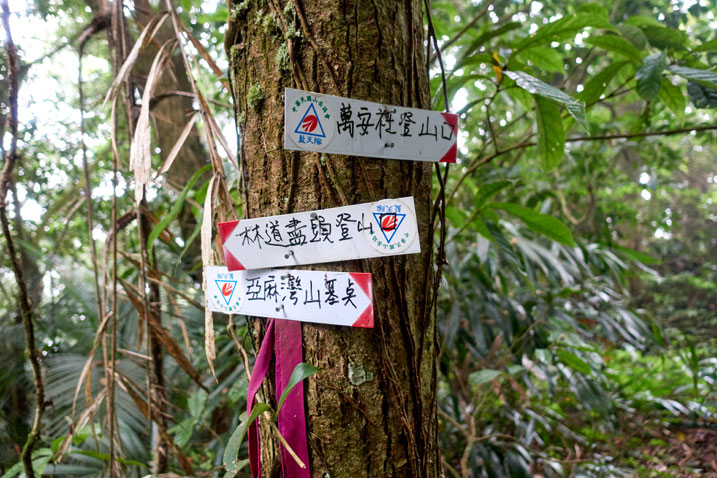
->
xmin=0 ymin=0 xmax=45 ymax=478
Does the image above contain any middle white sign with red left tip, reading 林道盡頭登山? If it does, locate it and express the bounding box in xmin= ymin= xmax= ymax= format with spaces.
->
xmin=217 ymin=197 xmax=421 ymax=271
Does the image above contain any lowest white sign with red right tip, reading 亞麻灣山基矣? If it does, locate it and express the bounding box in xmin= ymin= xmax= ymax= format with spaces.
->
xmin=205 ymin=266 xmax=373 ymax=328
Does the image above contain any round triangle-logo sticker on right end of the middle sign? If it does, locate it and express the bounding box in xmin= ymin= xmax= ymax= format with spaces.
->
xmin=363 ymin=199 xmax=418 ymax=255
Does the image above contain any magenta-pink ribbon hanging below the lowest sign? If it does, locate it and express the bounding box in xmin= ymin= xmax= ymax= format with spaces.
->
xmin=247 ymin=319 xmax=311 ymax=478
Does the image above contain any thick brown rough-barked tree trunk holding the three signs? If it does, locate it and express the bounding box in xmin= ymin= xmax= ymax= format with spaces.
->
xmin=225 ymin=0 xmax=440 ymax=478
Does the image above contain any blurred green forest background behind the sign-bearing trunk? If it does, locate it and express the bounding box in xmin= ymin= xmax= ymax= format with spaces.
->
xmin=0 ymin=0 xmax=717 ymax=478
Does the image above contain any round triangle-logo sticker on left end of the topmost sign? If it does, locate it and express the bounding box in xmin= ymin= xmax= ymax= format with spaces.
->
xmin=284 ymin=91 xmax=336 ymax=151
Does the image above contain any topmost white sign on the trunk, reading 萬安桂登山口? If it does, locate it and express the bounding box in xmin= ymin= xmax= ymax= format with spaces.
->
xmin=284 ymin=88 xmax=458 ymax=163
